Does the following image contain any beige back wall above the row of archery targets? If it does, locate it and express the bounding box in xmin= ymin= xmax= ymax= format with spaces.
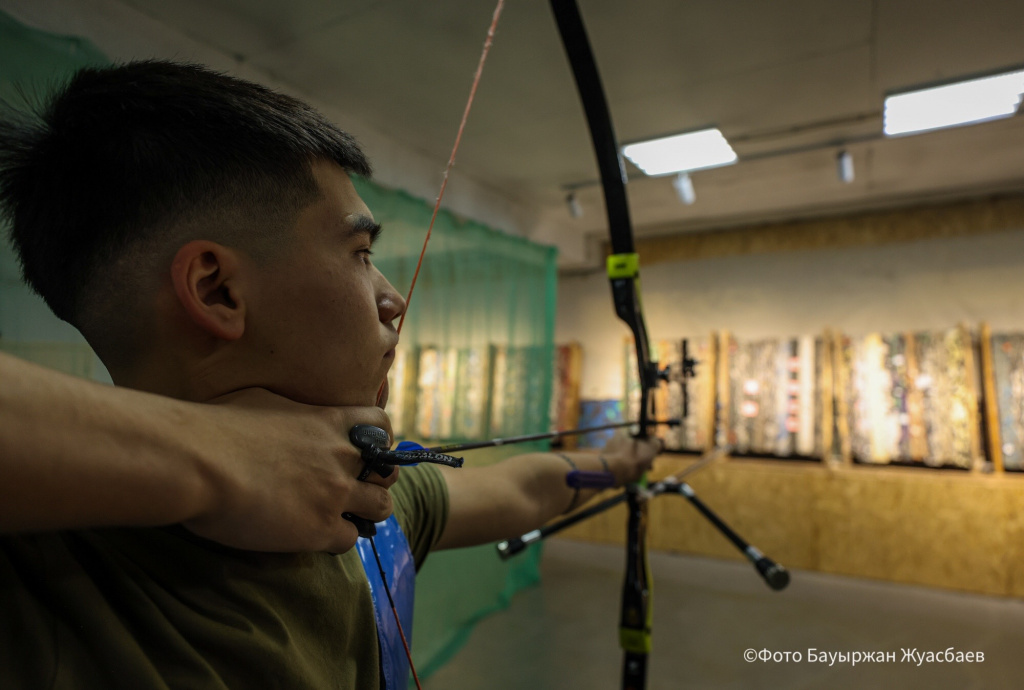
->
xmin=555 ymin=193 xmax=1024 ymax=399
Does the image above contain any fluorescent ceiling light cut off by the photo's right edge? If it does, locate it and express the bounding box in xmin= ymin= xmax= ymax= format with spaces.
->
xmin=885 ymin=71 xmax=1024 ymax=136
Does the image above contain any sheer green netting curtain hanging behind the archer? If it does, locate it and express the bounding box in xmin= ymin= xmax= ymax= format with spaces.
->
xmin=0 ymin=12 xmax=556 ymax=676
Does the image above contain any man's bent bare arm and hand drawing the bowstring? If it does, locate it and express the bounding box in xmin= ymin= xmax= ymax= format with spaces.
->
xmin=0 ymin=354 xmax=397 ymax=552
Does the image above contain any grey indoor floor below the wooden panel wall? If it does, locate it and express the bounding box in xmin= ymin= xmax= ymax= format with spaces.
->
xmin=424 ymin=540 xmax=1024 ymax=690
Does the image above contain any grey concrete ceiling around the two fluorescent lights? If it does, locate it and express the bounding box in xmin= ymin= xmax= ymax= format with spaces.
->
xmin=9 ymin=0 xmax=1024 ymax=266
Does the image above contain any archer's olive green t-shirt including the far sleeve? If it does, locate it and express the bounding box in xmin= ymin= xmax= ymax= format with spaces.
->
xmin=0 ymin=465 xmax=447 ymax=690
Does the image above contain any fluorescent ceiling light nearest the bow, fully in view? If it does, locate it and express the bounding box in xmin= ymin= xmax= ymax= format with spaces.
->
xmin=623 ymin=128 xmax=736 ymax=175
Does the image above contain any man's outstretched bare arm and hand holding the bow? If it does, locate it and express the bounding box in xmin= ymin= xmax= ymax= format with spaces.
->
xmin=436 ymin=435 xmax=662 ymax=549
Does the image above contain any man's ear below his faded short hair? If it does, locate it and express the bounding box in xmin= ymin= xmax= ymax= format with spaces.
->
xmin=171 ymin=240 xmax=246 ymax=340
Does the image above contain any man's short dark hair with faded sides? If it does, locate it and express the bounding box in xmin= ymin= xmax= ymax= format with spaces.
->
xmin=0 ymin=60 xmax=370 ymax=356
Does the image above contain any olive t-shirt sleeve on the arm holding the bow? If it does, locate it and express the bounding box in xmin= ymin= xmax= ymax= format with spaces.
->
xmin=391 ymin=464 xmax=449 ymax=570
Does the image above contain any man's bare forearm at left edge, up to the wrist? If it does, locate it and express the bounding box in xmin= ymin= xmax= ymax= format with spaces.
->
xmin=0 ymin=354 xmax=210 ymax=532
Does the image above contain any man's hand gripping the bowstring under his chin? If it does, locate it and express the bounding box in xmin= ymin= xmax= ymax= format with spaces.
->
xmin=184 ymin=383 xmax=399 ymax=553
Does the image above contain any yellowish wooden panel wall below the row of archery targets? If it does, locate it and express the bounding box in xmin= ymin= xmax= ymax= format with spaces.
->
xmin=565 ymin=456 xmax=1024 ymax=597
